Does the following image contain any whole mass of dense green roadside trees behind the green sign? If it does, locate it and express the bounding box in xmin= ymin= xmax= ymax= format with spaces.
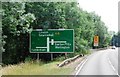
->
xmin=2 ymin=2 xmax=110 ymax=64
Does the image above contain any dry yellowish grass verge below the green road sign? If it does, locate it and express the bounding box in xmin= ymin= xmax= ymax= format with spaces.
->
xmin=2 ymin=62 xmax=74 ymax=75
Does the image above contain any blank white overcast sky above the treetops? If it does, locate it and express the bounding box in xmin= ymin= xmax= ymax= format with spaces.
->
xmin=78 ymin=0 xmax=119 ymax=32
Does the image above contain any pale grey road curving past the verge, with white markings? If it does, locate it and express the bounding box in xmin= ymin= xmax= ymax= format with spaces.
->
xmin=76 ymin=48 xmax=118 ymax=75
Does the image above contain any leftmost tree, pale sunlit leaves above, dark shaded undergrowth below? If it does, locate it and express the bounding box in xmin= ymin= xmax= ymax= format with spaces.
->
xmin=2 ymin=2 xmax=35 ymax=64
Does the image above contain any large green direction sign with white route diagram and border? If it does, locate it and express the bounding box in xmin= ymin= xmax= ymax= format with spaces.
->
xmin=30 ymin=29 xmax=74 ymax=53
